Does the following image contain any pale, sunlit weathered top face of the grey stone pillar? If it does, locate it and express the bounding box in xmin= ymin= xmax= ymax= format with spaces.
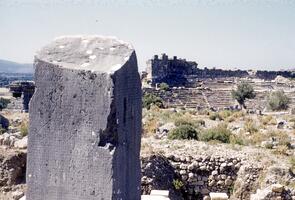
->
xmin=35 ymin=35 xmax=134 ymax=73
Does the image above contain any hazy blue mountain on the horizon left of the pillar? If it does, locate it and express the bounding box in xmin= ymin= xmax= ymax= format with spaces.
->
xmin=0 ymin=59 xmax=33 ymax=73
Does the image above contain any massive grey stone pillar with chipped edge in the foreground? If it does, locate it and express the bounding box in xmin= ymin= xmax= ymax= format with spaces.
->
xmin=27 ymin=36 xmax=141 ymax=200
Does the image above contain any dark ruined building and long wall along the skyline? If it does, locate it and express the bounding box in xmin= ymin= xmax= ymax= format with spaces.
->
xmin=147 ymin=54 xmax=295 ymax=86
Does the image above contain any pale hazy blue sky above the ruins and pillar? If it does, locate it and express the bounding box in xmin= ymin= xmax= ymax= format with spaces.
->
xmin=0 ymin=0 xmax=295 ymax=70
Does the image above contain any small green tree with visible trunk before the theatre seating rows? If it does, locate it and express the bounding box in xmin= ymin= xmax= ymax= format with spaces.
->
xmin=232 ymin=82 xmax=256 ymax=108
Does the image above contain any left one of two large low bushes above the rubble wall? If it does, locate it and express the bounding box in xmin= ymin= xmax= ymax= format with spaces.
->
xmin=168 ymin=125 xmax=198 ymax=140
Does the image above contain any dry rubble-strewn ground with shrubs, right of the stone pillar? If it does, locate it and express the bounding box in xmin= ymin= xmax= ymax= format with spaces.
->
xmin=141 ymin=102 xmax=295 ymax=200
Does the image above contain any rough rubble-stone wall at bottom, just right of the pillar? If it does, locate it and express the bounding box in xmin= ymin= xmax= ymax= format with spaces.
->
xmin=142 ymin=156 xmax=241 ymax=200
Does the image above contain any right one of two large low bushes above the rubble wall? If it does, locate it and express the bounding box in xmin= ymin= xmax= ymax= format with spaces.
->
xmin=200 ymin=124 xmax=232 ymax=143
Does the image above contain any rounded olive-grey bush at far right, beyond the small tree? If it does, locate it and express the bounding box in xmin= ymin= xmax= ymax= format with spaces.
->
xmin=267 ymin=90 xmax=290 ymax=111
